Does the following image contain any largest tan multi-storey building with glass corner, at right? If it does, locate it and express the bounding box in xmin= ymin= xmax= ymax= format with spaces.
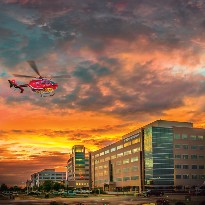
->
xmin=91 ymin=120 xmax=205 ymax=191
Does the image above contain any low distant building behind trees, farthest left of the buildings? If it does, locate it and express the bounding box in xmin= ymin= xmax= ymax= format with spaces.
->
xmin=31 ymin=169 xmax=66 ymax=187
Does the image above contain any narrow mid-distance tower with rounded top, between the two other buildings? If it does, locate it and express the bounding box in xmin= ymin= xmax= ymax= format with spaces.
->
xmin=66 ymin=145 xmax=90 ymax=189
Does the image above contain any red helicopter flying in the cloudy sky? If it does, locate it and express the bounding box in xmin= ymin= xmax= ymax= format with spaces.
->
xmin=8 ymin=60 xmax=70 ymax=97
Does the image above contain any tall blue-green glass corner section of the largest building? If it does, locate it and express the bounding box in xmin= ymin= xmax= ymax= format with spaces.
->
xmin=144 ymin=127 xmax=174 ymax=185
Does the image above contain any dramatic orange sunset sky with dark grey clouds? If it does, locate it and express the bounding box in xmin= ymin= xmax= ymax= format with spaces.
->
xmin=0 ymin=0 xmax=205 ymax=186
